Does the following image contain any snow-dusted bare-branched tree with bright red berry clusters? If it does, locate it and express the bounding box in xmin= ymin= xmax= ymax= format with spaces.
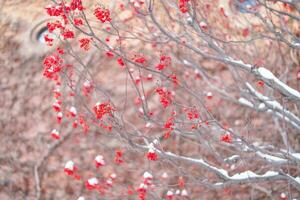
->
xmin=35 ymin=0 xmax=300 ymax=200
